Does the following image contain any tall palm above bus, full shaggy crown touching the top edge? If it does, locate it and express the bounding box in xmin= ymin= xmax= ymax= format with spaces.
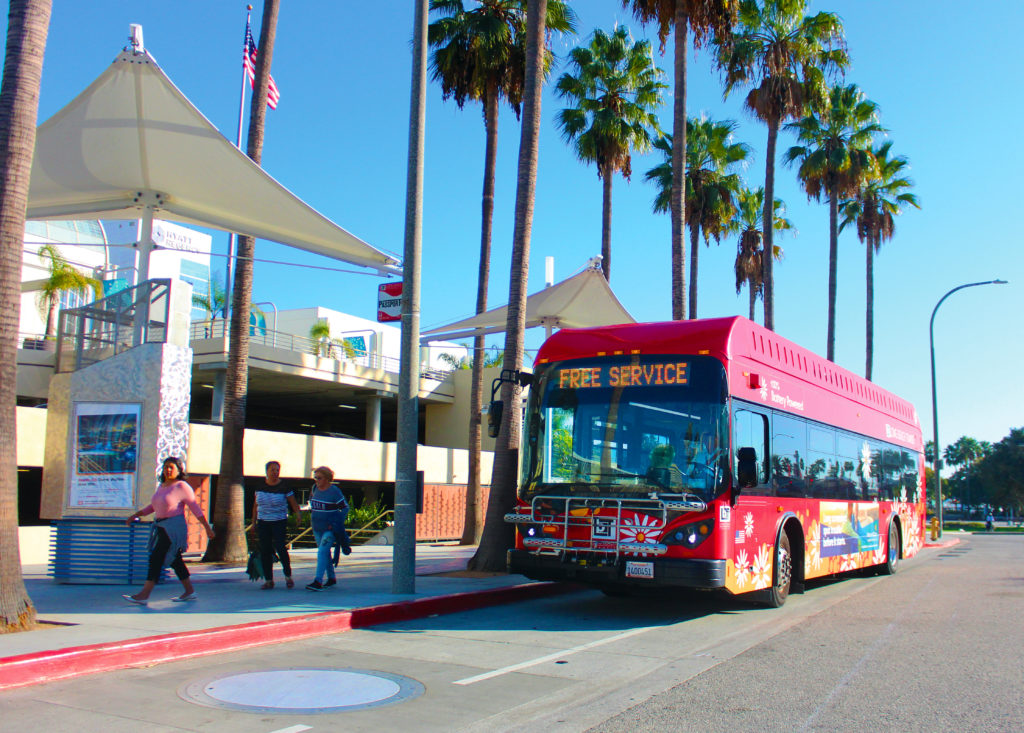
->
xmin=718 ymin=0 xmax=849 ymax=330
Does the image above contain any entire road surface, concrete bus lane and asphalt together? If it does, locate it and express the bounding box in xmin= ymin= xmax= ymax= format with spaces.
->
xmin=0 ymin=535 xmax=1024 ymax=733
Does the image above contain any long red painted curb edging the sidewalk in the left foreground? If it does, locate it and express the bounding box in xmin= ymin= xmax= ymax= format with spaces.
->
xmin=0 ymin=583 xmax=575 ymax=690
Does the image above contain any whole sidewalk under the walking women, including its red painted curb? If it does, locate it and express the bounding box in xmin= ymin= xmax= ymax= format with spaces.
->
xmin=0 ymin=545 xmax=569 ymax=690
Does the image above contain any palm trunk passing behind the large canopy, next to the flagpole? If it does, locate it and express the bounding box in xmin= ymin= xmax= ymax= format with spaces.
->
xmin=203 ymin=0 xmax=281 ymax=562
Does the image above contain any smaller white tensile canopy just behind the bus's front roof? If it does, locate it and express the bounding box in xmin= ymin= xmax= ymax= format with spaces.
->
xmin=420 ymin=257 xmax=636 ymax=343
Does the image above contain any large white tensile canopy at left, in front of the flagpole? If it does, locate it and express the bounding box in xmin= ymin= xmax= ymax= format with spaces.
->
xmin=28 ymin=48 xmax=398 ymax=277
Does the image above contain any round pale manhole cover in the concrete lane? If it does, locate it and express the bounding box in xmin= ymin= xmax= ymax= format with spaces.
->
xmin=179 ymin=670 xmax=423 ymax=715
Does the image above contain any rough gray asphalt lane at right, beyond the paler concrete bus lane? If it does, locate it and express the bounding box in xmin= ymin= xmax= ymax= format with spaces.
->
xmin=593 ymin=535 xmax=1024 ymax=733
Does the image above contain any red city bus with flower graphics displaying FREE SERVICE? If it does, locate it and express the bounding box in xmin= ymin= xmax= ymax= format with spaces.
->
xmin=505 ymin=317 xmax=926 ymax=606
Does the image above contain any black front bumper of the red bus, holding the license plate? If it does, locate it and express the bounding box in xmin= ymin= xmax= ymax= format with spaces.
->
xmin=508 ymin=550 xmax=725 ymax=588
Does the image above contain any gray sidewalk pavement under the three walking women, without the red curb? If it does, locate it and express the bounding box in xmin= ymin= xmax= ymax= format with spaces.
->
xmin=0 ymin=545 xmax=548 ymax=663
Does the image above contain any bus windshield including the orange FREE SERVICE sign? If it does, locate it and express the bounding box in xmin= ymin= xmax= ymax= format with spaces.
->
xmin=519 ymin=354 xmax=729 ymax=501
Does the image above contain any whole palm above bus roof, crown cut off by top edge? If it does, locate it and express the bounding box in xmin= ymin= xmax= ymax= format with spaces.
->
xmin=623 ymin=0 xmax=736 ymax=320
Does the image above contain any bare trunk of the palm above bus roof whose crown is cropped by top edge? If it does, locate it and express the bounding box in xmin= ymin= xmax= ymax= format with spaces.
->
xmin=672 ymin=2 xmax=689 ymax=320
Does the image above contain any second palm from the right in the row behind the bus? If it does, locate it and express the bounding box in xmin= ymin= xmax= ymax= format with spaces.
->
xmin=784 ymin=84 xmax=885 ymax=361
